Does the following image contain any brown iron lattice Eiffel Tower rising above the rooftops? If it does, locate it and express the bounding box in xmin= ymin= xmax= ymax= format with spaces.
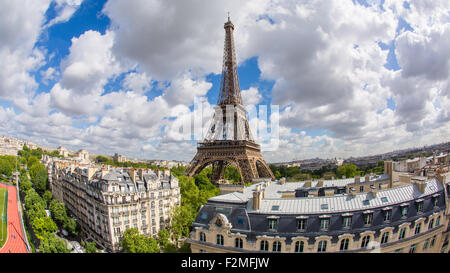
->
xmin=187 ymin=16 xmax=275 ymax=185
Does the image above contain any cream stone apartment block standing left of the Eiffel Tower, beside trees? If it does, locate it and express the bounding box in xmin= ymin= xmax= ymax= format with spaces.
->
xmin=51 ymin=161 xmax=181 ymax=252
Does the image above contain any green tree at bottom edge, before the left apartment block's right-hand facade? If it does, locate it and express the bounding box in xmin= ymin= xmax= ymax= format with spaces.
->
xmin=120 ymin=228 xmax=159 ymax=253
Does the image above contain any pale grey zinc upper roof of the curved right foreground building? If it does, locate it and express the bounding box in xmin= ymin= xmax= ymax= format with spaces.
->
xmin=253 ymin=178 xmax=442 ymax=214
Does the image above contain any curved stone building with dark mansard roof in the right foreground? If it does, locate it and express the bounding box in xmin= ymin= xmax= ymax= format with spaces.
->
xmin=188 ymin=159 xmax=450 ymax=253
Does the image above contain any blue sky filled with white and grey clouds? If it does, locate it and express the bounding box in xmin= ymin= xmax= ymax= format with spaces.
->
xmin=0 ymin=0 xmax=450 ymax=162
